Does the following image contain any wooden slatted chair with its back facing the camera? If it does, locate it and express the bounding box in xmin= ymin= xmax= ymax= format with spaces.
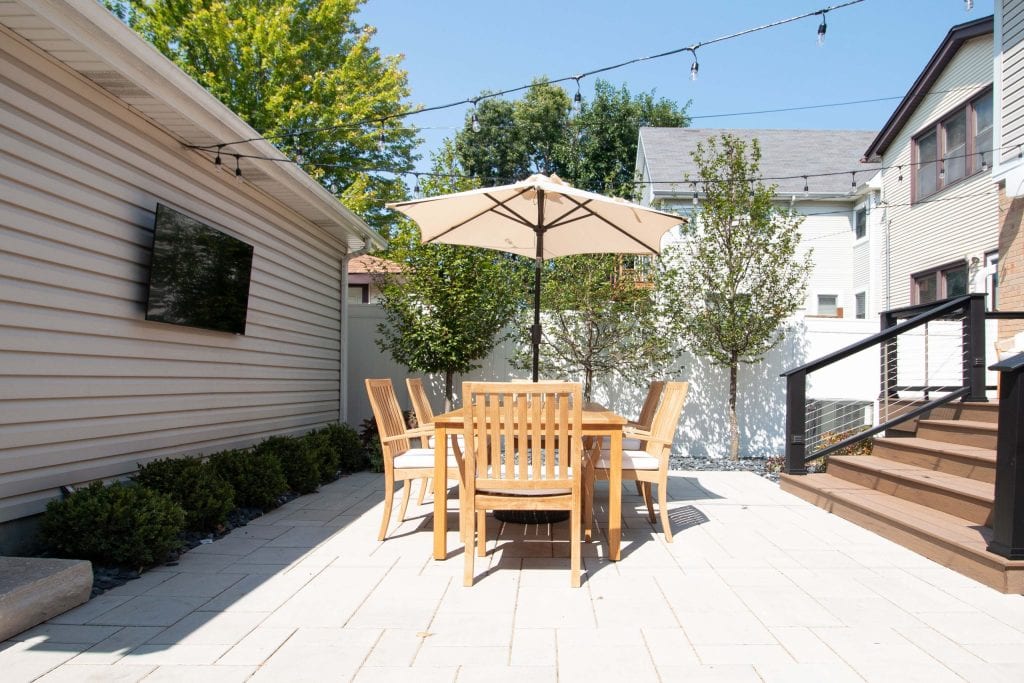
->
xmin=462 ymin=382 xmax=583 ymax=588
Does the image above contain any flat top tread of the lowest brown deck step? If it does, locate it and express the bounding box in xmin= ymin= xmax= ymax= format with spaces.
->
xmin=783 ymin=473 xmax=1024 ymax=569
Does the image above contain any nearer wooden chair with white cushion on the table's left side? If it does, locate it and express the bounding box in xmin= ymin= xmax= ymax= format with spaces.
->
xmin=366 ymin=379 xmax=459 ymax=541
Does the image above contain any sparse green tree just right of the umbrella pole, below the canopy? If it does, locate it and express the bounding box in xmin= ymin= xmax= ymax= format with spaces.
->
xmin=513 ymin=254 xmax=676 ymax=400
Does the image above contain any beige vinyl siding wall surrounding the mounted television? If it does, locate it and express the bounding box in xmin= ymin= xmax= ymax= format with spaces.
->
xmin=0 ymin=29 xmax=345 ymax=522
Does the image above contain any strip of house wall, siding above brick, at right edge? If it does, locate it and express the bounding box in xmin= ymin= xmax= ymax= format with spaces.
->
xmin=992 ymin=0 xmax=1024 ymax=339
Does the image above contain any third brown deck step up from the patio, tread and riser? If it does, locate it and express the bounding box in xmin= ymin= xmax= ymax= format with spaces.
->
xmin=871 ymin=436 xmax=995 ymax=483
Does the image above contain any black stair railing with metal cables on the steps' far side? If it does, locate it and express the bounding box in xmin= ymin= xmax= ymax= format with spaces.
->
xmin=780 ymin=293 xmax=987 ymax=474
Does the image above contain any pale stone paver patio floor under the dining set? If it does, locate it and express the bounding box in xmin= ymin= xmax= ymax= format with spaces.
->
xmin=6 ymin=472 xmax=1024 ymax=683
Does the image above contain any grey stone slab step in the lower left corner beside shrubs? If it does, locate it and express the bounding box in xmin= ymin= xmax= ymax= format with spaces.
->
xmin=0 ymin=557 xmax=92 ymax=641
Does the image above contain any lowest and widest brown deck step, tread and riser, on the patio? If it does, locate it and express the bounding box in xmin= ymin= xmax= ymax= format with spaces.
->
xmin=779 ymin=473 xmax=1024 ymax=594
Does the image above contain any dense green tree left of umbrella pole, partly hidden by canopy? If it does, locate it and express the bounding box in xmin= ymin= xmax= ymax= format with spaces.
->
xmin=375 ymin=142 xmax=524 ymax=409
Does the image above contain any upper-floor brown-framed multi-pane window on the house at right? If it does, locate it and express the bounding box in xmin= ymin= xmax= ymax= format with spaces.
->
xmin=913 ymin=90 xmax=992 ymax=201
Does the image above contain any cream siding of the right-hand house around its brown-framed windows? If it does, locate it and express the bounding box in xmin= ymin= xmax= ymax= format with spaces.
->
xmin=881 ymin=37 xmax=998 ymax=308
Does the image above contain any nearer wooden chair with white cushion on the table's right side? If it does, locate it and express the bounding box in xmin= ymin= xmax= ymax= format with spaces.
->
xmin=584 ymin=382 xmax=689 ymax=543
